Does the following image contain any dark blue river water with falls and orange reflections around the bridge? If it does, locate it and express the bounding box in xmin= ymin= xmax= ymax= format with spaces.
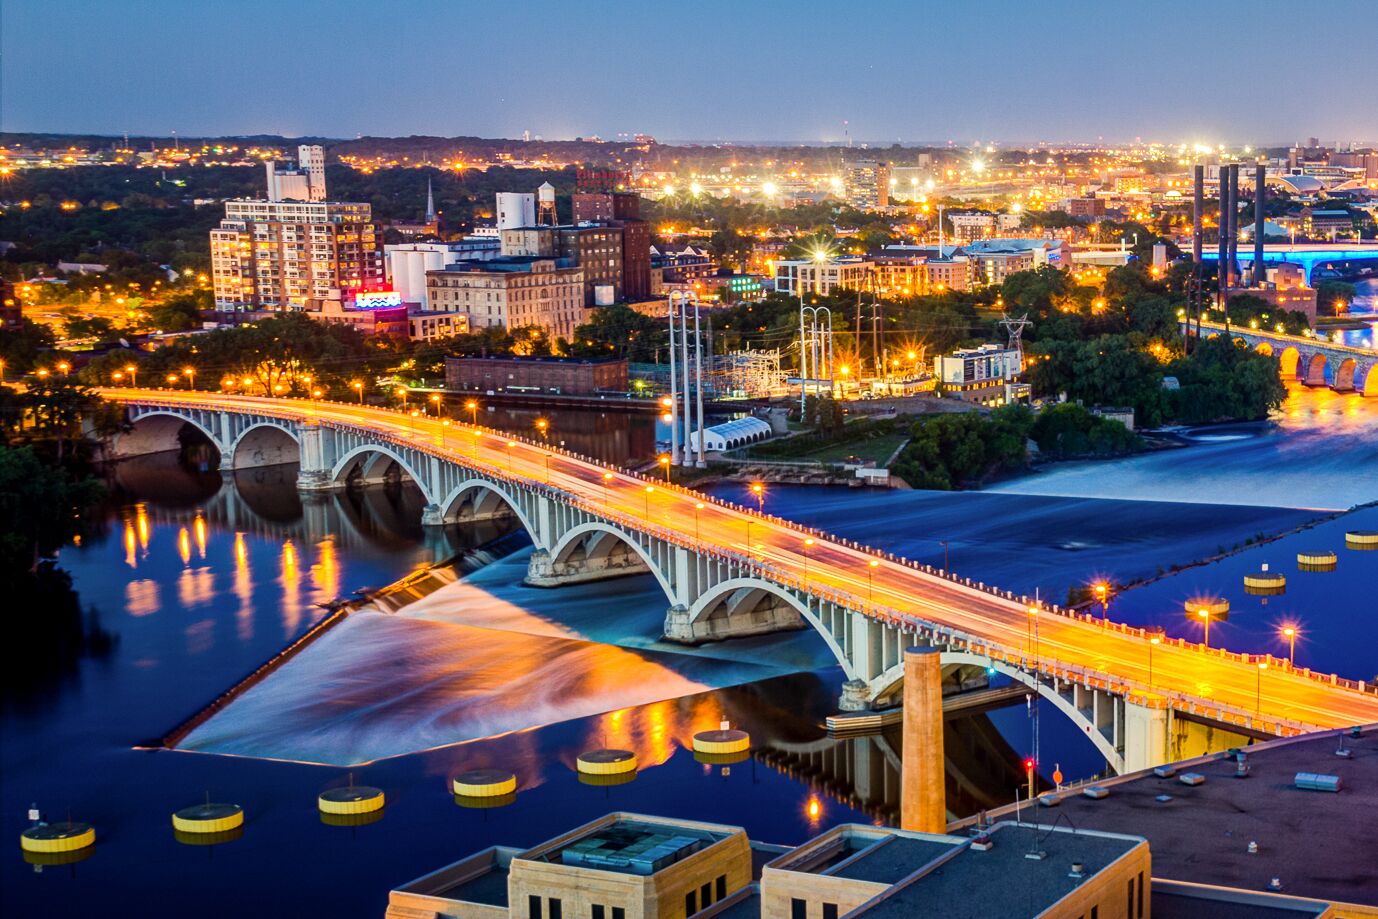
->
xmin=0 ymin=390 xmax=1378 ymax=916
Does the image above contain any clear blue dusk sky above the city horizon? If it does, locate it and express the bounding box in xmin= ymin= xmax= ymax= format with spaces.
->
xmin=8 ymin=0 xmax=1378 ymax=143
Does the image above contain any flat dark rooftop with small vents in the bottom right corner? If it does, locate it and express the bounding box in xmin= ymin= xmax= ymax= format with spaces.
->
xmin=970 ymin=725 xmax=1378 ymax=907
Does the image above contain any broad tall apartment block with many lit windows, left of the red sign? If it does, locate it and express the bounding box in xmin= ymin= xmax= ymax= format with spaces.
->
xmin=211 ymin=200 xmax=386 ymax=310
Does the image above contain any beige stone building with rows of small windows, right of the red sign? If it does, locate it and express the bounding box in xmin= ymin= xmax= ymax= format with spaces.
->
xmin=426 ymin=256 xmax=588 ymax=338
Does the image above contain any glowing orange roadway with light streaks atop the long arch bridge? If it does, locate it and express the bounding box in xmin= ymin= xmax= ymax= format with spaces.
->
xmin=102 ymin=389 xmax=1378 ymax=733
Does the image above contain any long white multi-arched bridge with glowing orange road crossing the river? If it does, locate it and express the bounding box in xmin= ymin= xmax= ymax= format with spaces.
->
xmin=105 ymin=390 xmax=1378 ymax=772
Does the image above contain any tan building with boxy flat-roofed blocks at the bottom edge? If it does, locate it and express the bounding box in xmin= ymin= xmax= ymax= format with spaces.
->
xmin=386 ymin=813 xmax=1152 ymax=919
